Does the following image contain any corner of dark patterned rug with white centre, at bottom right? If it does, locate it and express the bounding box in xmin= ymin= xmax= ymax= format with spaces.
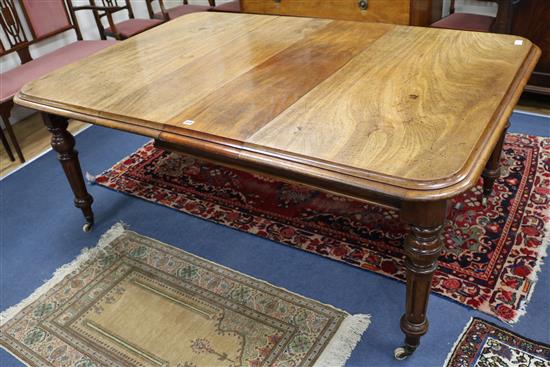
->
xmin=445 ymin=318 xmax=550 ymax=367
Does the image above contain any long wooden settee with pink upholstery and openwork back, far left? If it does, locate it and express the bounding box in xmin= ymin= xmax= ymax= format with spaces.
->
xmin=0 ymin=0 xmax=114 ymax=162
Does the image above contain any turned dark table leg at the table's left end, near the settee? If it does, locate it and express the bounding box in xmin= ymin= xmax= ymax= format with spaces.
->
xmin=42 ymin=113 xmax=94 ymax=232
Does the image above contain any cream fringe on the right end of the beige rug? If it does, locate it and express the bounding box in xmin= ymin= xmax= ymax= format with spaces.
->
xmin=314 ymin=314 xmax=370 ymax=367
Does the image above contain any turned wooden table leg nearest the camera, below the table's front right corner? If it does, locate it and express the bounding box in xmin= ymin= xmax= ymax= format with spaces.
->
xmin=395 ymin=201 xmax=447 ymax=359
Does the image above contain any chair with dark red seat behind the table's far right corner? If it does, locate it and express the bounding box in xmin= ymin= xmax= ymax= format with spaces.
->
xmin=431 ymin=0 xmax=520 ymax=33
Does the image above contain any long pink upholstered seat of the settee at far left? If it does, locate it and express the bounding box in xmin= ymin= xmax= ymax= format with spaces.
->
xmin=0 ymin=41 xmax=116 ymax=102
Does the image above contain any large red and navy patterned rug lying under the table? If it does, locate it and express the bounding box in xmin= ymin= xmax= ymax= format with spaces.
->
xmin=96 ymin=134 xmax=550 ymax=322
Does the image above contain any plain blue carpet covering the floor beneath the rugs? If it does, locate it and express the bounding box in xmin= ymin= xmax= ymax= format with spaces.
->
xmin=0 ymin=113 xmax=550 ymax=367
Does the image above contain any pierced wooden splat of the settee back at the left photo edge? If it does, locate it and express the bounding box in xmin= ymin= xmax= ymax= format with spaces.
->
xmin=0 ymin=0 xmax=32 ymax=63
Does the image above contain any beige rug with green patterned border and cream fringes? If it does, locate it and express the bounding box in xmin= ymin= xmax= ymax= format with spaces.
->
xmin=0 ymin=225 xmax=369 ymax=367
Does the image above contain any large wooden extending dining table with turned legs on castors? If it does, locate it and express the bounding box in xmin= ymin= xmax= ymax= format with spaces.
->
xmin=15 ymin=12 xmax=540 ymax=359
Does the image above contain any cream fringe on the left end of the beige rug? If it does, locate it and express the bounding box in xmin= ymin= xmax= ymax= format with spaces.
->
xmin=0 ymin=223 xmax=124 ymax=327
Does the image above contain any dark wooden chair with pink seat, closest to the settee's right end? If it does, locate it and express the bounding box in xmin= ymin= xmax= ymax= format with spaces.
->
xmin=88 ymin=0 xmax=163 ymax=40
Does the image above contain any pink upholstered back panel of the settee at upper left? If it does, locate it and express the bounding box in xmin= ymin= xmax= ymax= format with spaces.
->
xmin=20 ymin=0 xmax=82 ymax=41
